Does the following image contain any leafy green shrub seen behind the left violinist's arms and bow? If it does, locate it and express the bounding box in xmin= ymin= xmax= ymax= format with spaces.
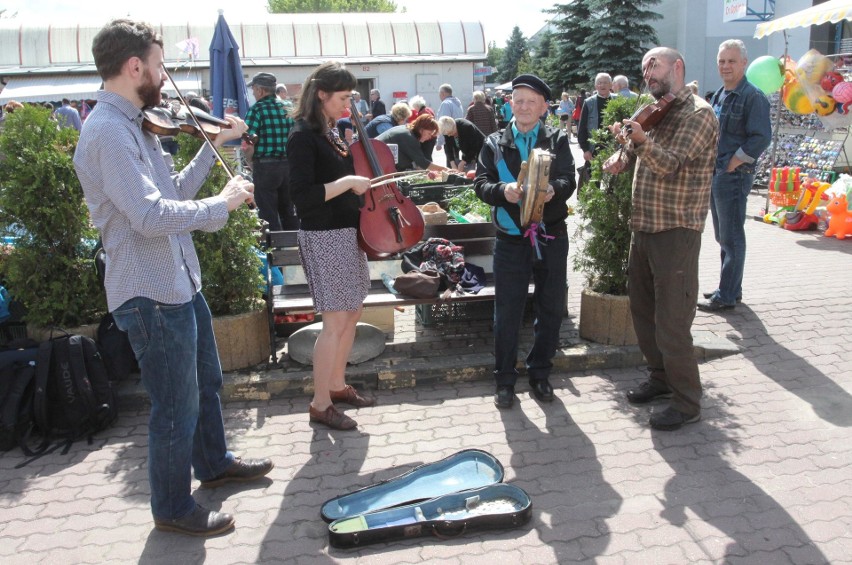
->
xmin=175 ymin=134 xmax=264 ymax=316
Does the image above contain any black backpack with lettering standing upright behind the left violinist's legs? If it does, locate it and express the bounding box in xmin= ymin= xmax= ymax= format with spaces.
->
xmin=33 ymin=335 xmax=118 ymax=454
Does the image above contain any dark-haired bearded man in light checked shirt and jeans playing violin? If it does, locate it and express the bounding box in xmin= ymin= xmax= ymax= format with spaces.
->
xmin=74 ymin=20 xmax=273 ymax=536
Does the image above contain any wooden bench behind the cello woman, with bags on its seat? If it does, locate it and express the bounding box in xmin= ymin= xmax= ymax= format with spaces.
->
xmin=266 ymin=222 xmax=533 ymax=361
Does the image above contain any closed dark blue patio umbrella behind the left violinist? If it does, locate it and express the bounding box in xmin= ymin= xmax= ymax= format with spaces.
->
xmin=210 ymin=10 xmax=248 ymax=118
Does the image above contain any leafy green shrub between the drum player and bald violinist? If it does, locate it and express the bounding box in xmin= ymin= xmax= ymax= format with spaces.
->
xmin=574 ymin=93 xmax=650 ymax=295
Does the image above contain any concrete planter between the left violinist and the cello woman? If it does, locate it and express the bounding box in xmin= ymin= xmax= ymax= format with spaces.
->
xmin=213 ymin=310 xmax=269 ymax=372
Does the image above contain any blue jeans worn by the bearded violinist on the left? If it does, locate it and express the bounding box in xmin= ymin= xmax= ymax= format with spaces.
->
xmin=113 ymin=292 xmax=234 ymax=520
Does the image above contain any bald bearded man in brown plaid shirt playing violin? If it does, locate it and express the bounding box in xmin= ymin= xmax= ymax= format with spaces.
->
xmin=604 ymin=47 xmax=718 ymax=430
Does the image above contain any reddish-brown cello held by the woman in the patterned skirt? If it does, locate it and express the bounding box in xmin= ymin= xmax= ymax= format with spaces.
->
xmin=349 ymin=100 xmax=425 ymax=259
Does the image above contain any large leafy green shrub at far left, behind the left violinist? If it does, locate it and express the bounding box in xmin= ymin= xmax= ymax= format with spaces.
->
xmin=0 ymin=106 xmax=106 ymax=327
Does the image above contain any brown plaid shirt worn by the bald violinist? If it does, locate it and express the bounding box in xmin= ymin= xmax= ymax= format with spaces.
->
xmin=626 ymin=87 xmax=719 ymax=233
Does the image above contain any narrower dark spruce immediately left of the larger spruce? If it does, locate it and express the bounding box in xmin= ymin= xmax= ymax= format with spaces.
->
xmin=548 ymin=0 xmax=591 ymax=90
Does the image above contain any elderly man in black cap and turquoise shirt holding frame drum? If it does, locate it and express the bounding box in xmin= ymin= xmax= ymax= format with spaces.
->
xmin=474 ymin=74 xmax=576 ymax=408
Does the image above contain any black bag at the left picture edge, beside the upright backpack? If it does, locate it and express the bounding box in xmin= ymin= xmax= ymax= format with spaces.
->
xmin=0 ymin=348 xmax=38 ymax=451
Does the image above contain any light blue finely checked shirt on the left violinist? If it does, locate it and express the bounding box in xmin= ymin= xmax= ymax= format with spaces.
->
xmin=74 ymin=90 xmax=228 ymax=312
